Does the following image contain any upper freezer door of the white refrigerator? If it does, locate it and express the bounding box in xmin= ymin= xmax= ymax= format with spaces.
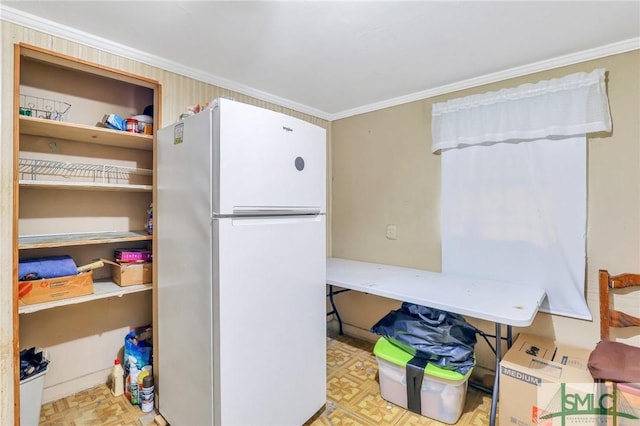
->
xmin=211 ymin=99 xmax=326 ymax=215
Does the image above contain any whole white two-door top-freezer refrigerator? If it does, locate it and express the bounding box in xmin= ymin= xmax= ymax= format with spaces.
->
xmin=154 ymin=99 xmax=326 ymax=426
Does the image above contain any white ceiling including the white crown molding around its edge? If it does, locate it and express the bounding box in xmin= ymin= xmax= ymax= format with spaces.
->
xmin=0 ymin=0 xmax=640 ymax=119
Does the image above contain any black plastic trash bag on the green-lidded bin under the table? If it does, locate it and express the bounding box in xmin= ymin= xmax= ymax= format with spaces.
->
xmin=371 ymin=302 xmax=477 ymax=374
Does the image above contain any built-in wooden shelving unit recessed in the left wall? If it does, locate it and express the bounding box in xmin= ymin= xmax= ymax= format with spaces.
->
xmin=13 ymin=44 xmax=161 ymax=424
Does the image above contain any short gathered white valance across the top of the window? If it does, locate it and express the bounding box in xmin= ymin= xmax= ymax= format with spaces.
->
xmin=431 ymin=69 xmax=611 ymax=152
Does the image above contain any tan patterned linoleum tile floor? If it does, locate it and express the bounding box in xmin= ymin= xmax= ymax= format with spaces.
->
xmin=40 ymin=335 xmax=491 ymax=426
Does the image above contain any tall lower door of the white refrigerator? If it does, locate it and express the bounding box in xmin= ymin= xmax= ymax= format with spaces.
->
xmin=213 ymin=215 xmax=326 ymax=426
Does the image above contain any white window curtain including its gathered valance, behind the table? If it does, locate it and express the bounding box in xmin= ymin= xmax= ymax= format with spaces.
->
xmin=432 ymin=69 xmax=611 ymax=319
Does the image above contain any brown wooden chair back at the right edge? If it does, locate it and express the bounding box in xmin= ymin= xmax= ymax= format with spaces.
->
xmin=600 ymin=269 xmax=640 ymax=340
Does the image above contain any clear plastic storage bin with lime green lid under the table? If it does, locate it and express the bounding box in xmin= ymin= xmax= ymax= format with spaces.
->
xmin=373 ymin=337 xmax=472 ymax=424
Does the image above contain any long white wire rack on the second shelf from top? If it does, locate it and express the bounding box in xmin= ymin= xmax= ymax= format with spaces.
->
xmin=18 ymin=158 xmax=153 ymax=184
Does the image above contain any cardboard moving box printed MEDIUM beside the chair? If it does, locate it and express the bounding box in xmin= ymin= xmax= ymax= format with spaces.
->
xmin=499 ymin=334 xmax=606 ymax=426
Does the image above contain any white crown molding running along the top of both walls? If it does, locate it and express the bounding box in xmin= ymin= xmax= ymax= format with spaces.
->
xmin=0 ymin=3 xmax=640 ymax=121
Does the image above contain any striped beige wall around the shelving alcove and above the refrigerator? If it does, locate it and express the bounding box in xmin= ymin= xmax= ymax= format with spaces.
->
xmin=0 ymin=21 xmax=331 ymax=425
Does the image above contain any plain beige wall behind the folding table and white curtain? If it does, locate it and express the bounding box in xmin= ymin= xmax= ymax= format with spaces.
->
xmin=331 ymin=50 xmax=640 ymax=380
